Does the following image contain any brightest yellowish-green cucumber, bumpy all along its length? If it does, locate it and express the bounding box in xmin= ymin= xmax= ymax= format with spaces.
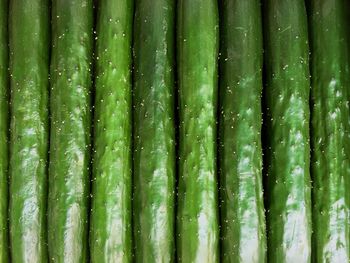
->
xmin=90 ymin=0 xmax=133 ymax=262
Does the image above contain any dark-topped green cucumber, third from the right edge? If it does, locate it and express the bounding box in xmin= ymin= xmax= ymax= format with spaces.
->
xmin=219 ymin=0 xmax=266 ymax=262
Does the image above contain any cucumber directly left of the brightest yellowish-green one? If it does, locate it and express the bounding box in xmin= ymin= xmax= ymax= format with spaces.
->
xmin=48 ymin=0 xmax=93 ymax=262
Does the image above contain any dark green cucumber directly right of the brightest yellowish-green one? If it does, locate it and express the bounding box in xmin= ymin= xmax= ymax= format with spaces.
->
xmin=133 ymin=0 xmax=175 ymax=262
